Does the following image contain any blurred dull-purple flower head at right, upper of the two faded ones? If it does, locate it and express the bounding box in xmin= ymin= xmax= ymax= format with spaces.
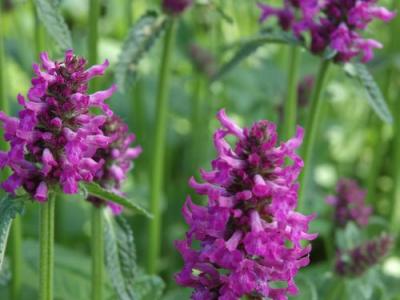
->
xmin=326 ymin=179 xmax=372 ymax=227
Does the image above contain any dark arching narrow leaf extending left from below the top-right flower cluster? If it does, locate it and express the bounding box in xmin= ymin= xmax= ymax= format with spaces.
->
xmin=211 ymin=30 xmax=301 ymax=81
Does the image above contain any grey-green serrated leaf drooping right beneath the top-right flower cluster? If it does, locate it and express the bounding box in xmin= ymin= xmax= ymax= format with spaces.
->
xmin=353 ymin=63 xmax=393 ymax=123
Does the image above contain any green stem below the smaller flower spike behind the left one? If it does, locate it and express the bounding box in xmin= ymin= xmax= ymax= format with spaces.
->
xmin=92 ymin=206 xmax=104 ymax=300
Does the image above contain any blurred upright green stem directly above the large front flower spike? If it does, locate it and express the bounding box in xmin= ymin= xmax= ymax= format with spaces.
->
xmin=283 ymin=46 xmax=300 ymax=139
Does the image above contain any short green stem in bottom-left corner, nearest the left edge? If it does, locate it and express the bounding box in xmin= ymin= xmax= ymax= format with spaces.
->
xmin=11 ymin=216 xmax=22 ymax=300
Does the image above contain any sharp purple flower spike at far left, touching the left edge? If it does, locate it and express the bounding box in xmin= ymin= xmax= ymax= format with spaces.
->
xmin=0 ymin=51 xmax=115 ymax=201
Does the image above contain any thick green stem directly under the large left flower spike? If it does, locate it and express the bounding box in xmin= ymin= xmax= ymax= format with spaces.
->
xmin=39 ymin=193 xmax=55 ymax=300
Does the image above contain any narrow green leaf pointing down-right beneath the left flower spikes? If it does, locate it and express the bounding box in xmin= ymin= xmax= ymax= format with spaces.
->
xmin=81 ymin=182 xmax=153 ymax=218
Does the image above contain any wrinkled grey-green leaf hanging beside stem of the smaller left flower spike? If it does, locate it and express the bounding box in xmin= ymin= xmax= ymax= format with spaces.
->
xmin=104 ymin=212 xmax=139 ymax=300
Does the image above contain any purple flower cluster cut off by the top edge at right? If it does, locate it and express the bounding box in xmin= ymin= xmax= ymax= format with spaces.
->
xmin=259 ymin=0 xmax=395 ymax=62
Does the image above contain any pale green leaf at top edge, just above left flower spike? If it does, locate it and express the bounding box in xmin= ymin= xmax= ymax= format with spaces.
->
xmin=35 ymin=0 xmax=72 ymax=50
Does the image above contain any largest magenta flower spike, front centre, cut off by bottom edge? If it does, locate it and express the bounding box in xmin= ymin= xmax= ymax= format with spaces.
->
xmin=176 ymin=110 xmax=316 ymax=300
